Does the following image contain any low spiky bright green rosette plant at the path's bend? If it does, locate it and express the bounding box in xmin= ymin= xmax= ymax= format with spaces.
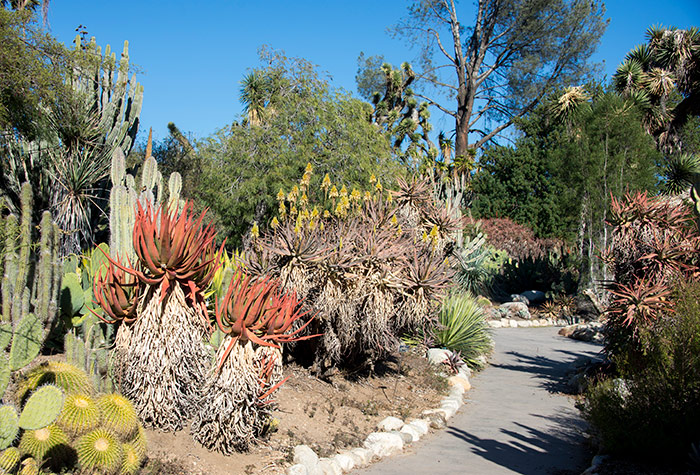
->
xmin=430 ymin=294 xmax=493 ymax=368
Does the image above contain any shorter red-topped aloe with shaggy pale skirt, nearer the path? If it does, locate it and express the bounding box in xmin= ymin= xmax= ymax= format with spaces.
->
xmin=192 ymin=271 xmax=318 ymax=454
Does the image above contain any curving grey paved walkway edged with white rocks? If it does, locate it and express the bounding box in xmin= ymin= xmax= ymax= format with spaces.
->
xmin=355 ymin=327 xmax=602 ymax=475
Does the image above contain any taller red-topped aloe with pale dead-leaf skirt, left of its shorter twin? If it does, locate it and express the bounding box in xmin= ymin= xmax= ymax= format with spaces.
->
xmin=95 ymin=203 xmax=223 ymax=430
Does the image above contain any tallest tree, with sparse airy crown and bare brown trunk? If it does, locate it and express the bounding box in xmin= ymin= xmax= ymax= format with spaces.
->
xmin=394 ymin=0 xmax=606 ymax=157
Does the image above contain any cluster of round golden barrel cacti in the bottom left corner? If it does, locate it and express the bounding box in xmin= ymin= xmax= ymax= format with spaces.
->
xmin=9 ymin=362 xmax=146 ymax=475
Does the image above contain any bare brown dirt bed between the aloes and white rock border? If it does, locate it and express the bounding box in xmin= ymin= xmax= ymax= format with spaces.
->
xmin=141 ymin=350 xmax=447 ymax=475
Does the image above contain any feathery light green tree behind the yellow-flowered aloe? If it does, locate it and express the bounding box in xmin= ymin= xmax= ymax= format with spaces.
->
xmin=197 ymin=50 xmax=402 ymax=245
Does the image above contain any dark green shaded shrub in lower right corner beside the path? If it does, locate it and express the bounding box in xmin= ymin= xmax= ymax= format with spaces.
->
xmin=581 ymin=283 xmax=700 ymax=461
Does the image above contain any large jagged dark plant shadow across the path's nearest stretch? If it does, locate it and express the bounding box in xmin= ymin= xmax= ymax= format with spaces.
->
xmin=447 ymin=409 xmax=585 ymax=475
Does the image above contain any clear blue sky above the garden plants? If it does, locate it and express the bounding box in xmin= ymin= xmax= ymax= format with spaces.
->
xmin=49 ymin=0 xmax=700 ymax=145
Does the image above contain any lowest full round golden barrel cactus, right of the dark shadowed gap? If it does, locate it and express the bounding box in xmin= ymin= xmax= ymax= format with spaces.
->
xmin=75 ymin=428 xmax=122 ymax=474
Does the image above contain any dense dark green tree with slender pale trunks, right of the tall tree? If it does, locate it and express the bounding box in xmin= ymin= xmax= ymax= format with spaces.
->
xmin=473 ymin=88 xmax=660 ymax=285
